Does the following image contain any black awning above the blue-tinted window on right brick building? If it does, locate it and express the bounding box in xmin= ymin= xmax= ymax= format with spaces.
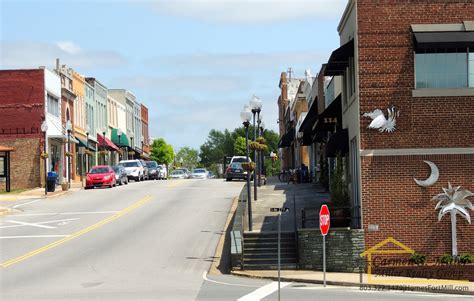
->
xmin=413 ymin=31 xmax=474 ymax=50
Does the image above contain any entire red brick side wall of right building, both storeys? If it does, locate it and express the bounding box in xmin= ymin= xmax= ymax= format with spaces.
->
xmin=357 ymin=0 xmax=474 ymax=257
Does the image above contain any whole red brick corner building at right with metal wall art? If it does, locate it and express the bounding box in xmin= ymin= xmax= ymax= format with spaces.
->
xmin=325 ymin=0 xmax=474 ymax=260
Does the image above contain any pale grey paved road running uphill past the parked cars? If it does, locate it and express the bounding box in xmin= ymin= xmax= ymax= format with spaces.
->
xmin=0 ymin=180 xmax=243 ymax=301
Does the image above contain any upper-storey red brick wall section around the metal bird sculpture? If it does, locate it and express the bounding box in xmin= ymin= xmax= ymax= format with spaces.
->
xmin=358 ymin=0 xmax=474 ymax=149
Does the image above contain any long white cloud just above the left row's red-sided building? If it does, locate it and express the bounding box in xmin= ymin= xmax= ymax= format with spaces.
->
xmin=0 ymin=41 xmax=126 ymax=69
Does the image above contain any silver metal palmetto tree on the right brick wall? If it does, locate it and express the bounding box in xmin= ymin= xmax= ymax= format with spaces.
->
xmin=433 ymin=183 xmax=474 ymax=256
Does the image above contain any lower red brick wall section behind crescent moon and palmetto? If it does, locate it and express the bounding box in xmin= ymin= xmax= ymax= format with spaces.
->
xmin=361 ymin=155 xmax=474 ymax=259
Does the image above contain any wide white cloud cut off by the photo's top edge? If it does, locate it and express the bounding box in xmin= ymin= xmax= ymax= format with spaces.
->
xmin=143 ymin=0 xmax=347 ymax=24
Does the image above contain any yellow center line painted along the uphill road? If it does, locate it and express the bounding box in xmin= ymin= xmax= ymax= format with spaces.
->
xmin=0 ymin=195 xmax=152 ymax=268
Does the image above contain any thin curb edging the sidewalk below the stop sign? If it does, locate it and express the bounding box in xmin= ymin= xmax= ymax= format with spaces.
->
xmin=231 ymin=271 xmax=474 ymax=296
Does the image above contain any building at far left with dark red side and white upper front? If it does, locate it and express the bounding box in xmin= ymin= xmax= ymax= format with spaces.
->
xmin=0 ymin=68 xmax=65 ymax=189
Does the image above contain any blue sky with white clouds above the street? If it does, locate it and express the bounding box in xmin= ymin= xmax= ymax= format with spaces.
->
xmin=0 ymin=0 xmax=347 ymax=150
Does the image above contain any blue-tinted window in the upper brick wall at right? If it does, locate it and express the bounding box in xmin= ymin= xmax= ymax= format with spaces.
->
xmin=415 ymin=48 xmax=474 ymax=89
